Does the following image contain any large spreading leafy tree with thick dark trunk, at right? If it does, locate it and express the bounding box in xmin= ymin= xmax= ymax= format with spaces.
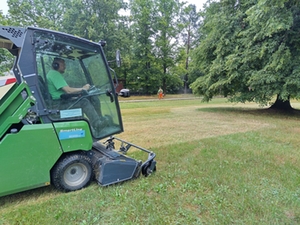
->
xmin=191 ymin=0 xmax=300 ymax=108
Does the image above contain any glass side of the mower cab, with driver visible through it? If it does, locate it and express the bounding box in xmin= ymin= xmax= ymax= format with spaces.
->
xmin=34 ymin=31 xmax=123 ymax=138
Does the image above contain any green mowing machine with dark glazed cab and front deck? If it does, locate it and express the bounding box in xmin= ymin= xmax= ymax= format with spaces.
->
xmin=0 ymin=26 xmax=156 ymax=196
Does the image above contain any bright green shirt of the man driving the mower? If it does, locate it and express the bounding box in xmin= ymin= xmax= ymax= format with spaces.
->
xmin=47 ymin=70 xmax=68 ymax=100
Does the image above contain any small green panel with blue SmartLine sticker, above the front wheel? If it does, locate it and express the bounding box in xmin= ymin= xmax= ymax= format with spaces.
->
xmin=53 ymin=121 xmax=93 ymax=152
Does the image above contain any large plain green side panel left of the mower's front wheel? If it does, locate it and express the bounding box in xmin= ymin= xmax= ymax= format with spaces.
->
xmin=0 ymin=124 xmax=62 ymax=196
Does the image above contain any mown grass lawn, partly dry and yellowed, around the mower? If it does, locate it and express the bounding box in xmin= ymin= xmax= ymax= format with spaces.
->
xmin=0 ymin=95 xmax=300 ymax=225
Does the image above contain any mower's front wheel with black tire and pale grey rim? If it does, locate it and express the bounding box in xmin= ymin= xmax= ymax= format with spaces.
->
xmin=51 ymin=154 xmax=93 ymax=192
